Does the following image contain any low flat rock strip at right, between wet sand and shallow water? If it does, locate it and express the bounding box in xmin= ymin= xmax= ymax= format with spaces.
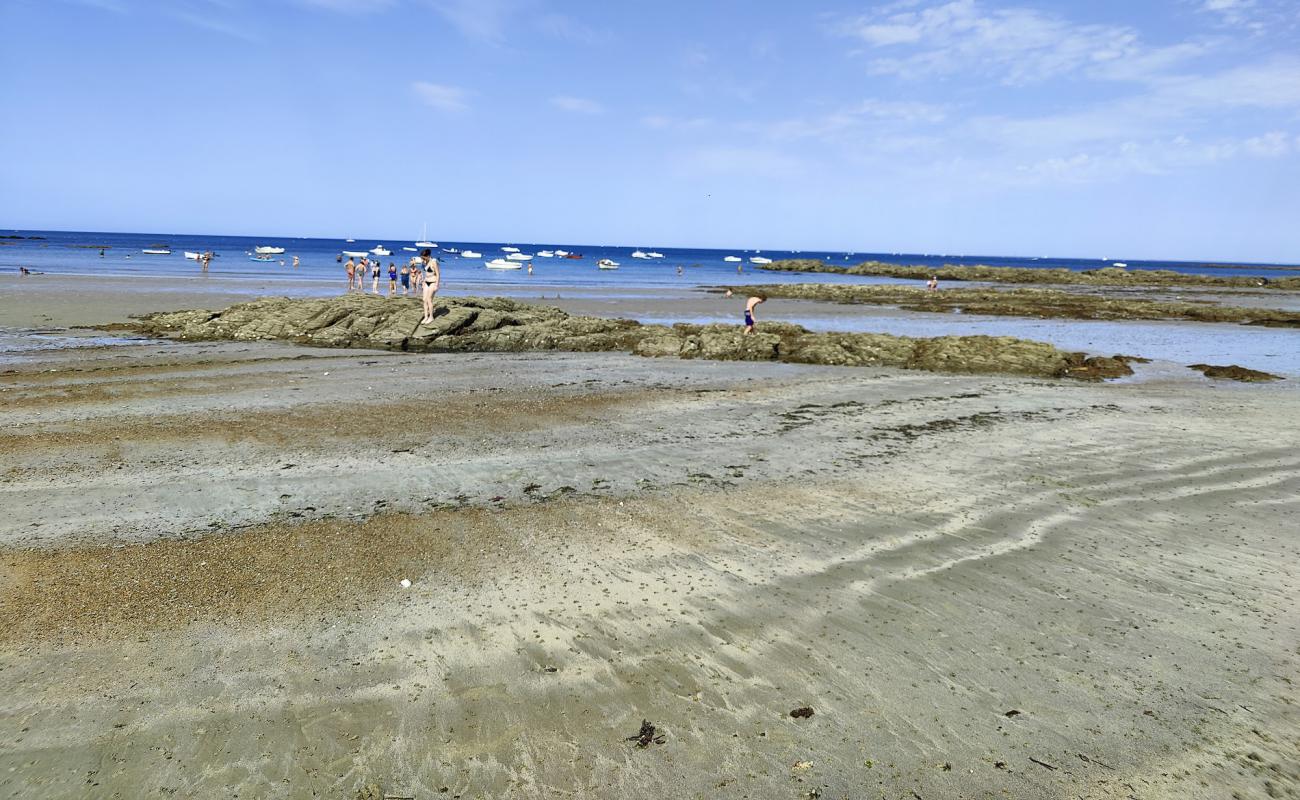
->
xmin=732 ymin=284 xmax=1300 ymax=328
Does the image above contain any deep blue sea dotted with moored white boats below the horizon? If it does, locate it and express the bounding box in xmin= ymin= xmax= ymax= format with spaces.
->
xmin=0 ymin=230 xmax=1300 ymax=287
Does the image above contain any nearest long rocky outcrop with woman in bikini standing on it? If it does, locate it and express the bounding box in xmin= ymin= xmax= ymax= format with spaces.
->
xmin=131 ymin=295 xmax=1144 ymax=380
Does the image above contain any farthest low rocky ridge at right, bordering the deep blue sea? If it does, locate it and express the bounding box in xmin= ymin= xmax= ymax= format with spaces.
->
xmin=759 ymin=259 xmax=1300 ymax=290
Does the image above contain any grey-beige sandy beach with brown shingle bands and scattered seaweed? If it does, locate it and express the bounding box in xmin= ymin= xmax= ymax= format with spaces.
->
xmin=0 ymin=278 xmax=1300 ymax=800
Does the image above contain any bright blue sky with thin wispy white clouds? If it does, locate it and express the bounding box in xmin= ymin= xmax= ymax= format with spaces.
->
xmin=0 ymin=0 xmax=1300 ymax=261
